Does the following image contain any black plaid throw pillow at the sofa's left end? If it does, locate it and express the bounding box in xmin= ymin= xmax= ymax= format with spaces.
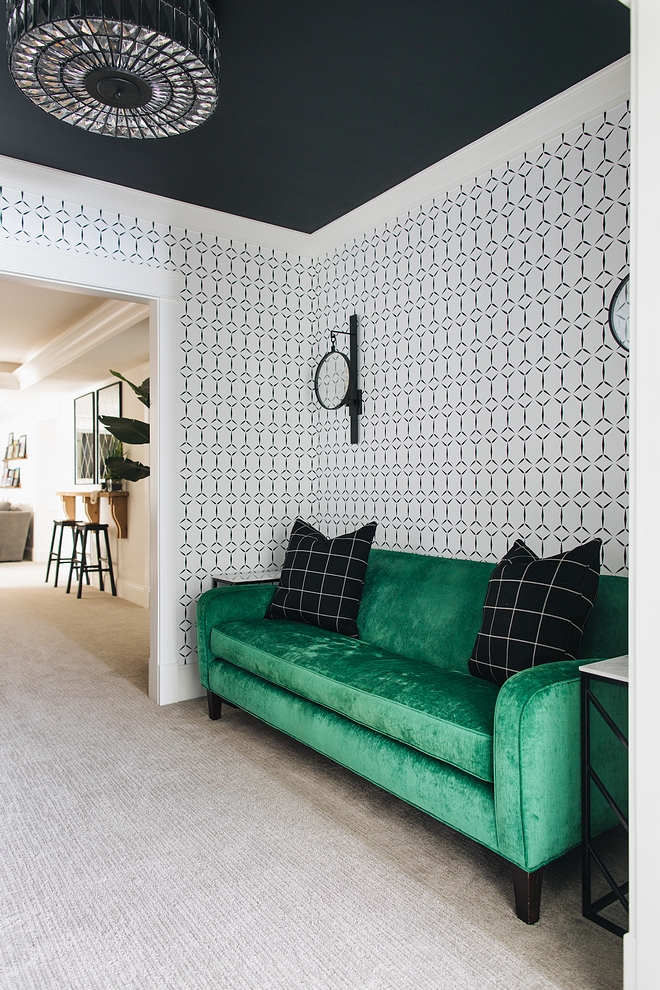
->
xmin=266 ymin=519 xmax=376 ymax=638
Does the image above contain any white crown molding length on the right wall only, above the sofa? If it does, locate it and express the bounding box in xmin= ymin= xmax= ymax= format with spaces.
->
xmin=311 ymin=55 xmax=630 ymax=257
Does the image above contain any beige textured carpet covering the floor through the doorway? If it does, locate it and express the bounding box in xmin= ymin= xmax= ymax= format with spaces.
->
xmin=0 ymin=565 xmax=621 ymax=990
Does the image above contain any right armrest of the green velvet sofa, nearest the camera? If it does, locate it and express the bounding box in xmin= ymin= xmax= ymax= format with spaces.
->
xmin=493 ymin=660 xmax=585 ymax=873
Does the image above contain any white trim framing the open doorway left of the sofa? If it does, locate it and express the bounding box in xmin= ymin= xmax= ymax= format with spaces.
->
xmin=0 ymin=242 xmax=183 ymax=705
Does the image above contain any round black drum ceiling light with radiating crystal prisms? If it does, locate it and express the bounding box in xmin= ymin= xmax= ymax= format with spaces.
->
xmin=7 ymin=0 xmax=220 ymax=138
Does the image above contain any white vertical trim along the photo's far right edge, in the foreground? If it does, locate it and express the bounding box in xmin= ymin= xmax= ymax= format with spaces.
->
xmin=624 ymin=0 xmax=660 ymax=990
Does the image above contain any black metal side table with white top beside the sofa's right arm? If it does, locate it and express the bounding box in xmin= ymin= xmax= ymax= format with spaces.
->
xmin=580 ymin=657 xmax=629 ymax=937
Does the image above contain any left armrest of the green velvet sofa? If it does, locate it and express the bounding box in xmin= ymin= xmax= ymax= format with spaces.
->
xmin=197 ymin=584 xmax=275 ymax=690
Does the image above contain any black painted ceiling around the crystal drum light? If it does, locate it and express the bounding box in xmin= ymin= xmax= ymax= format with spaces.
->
xmin=0 ymin=0 xmax=630 ymax=232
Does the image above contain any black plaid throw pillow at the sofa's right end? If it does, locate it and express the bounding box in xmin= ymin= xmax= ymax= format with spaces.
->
xmin=468 ymin=540 xmax=601 ymax=684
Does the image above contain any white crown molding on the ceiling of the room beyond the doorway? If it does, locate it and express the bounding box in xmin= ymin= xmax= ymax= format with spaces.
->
xmin=12 ymin=299 xmax=149 ymax=391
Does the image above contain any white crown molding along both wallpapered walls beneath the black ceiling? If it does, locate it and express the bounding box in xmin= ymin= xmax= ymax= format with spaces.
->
xmin=0 ymin=56 xmax=630 ymax=264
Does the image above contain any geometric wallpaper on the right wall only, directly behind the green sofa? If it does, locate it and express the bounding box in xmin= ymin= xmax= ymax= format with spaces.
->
xmin=312 ymin=105 xmax=629 ymax=574
